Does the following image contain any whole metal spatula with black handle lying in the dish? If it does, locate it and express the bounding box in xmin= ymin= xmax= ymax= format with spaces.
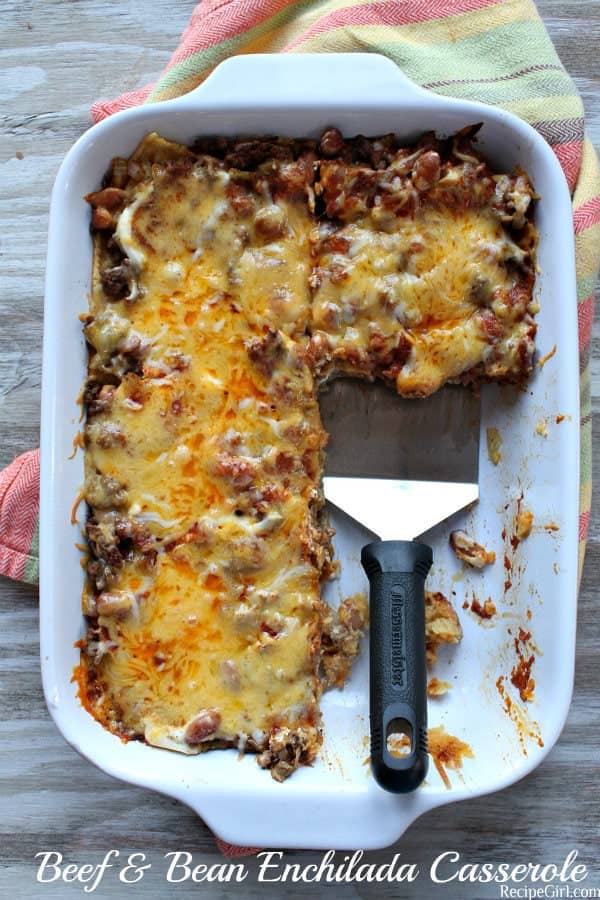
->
xmin=320 ymin=379 xmax=479 ymax=793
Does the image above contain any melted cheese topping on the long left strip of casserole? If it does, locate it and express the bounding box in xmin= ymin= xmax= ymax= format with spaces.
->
xmin=86 ymin=139 xmax=323 ymax=752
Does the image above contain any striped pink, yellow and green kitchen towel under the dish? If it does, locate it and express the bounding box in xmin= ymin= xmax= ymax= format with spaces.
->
xmin=0 ymin=0 xmax=600 ymax=855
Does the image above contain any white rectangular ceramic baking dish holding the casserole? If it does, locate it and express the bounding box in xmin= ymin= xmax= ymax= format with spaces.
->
xmin=40 ymin=54 xmax=579 ymax=848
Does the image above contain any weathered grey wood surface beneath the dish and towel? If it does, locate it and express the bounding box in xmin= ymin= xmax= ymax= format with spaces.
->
xmin=0 ymin=0 xmax=600 ymax=900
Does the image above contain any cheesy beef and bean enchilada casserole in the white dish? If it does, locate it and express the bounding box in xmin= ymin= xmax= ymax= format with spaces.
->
xmin=76 ymin=128 xmax=536 ymax=780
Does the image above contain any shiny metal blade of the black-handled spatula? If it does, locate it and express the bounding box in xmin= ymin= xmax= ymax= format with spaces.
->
xmin=320 ymin=379 xmax=480 ymax=540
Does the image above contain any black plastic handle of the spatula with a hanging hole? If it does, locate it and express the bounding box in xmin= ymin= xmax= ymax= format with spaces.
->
xmin=361 ymin=541 xmax=433 ymax=794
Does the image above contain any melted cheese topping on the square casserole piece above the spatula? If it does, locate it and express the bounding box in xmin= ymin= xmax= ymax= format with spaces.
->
xmin=312 ymin=176 xmax=533 ymax=397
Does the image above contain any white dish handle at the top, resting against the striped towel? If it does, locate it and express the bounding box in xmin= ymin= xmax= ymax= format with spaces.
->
xmin=171 ymin=53 xmax=427 ymax=109
